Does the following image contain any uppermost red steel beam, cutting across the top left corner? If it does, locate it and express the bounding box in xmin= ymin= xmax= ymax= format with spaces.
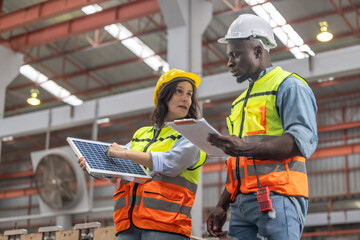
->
xmin=0 ymin=0 xmax=107 ymax=33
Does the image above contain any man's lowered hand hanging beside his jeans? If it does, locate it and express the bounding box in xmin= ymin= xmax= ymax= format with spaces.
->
xmin=207 ymin=206 xmax=227 ymax=237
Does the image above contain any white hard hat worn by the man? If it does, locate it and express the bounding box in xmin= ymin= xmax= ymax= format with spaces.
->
xmin=218 ymin=14 xmax=276 ymax=49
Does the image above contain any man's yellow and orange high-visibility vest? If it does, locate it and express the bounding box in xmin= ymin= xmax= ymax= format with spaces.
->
xmin=226 ymin=67 xmax=308 ymax=201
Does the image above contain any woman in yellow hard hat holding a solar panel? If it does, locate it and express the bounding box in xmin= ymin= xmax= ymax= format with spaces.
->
xmin=79 ymin=69 xmax=206 ymax=240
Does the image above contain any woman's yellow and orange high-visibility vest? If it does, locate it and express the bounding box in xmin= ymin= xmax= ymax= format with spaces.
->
xmin=114 ymin=124 xmax=206 ymax=237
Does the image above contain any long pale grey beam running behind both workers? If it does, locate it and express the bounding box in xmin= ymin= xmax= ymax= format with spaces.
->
xmin=0 ymin=46 xmax=360 ymax=137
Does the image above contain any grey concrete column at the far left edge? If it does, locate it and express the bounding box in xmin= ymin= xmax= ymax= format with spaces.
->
xmin=0 ymin=45 xmax=23 ymax=119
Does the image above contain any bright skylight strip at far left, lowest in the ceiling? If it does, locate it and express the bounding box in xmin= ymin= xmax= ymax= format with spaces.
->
xmin=20 ymin=65 xmax=83 ymax=106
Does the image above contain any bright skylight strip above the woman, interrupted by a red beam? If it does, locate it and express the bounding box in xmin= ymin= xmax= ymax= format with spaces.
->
xmin=81 ymin=4 xmax=169 ymax=72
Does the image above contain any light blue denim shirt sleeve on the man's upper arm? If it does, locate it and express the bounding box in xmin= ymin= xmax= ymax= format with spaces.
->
xmin=276 ymin=76 xmax=318 ymax=158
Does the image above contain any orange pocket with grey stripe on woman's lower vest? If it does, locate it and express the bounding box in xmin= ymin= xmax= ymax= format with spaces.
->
xmin=139 ymin=186 xmax=184 ymax=223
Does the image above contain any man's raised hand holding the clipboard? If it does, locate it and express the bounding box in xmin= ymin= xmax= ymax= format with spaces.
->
xmin=207 ymin=134 xmax=251 ymax=157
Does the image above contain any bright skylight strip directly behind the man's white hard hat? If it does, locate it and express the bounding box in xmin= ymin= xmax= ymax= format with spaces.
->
xmin=245 ymin=0 xmax=315 ymax=59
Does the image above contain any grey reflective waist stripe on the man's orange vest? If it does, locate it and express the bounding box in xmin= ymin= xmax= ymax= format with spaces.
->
xmin=233 ymin=161 xmax=307 ymax=178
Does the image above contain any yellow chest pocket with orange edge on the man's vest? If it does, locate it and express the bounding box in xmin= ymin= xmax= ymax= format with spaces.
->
xmin=244 ymin=99 xmax=267 ymax=136
